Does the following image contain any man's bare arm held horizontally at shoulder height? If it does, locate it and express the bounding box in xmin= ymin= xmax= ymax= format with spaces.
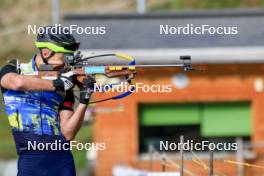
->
xmin=1 ymin=73 xmax=55 ymax=91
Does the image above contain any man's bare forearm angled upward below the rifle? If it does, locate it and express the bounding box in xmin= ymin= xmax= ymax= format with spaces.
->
xmin=59 ymin=103 xmax=87 ymax=140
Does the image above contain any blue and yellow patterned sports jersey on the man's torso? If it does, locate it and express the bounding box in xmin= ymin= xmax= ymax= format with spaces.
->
xmin=0 ymin=56 xmax=74 ymax=153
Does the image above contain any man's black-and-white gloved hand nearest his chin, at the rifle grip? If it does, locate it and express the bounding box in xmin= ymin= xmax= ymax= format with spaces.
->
xmin=53 ymin=71 xmax=77 ymax=91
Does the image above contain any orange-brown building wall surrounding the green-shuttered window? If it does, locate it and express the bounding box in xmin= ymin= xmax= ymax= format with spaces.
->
xmin=93 ymin=64 xmax=264 ymax=176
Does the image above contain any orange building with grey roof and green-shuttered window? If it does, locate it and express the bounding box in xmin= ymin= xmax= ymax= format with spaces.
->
xmin=65 ymin=10 xmax=264 ymax=176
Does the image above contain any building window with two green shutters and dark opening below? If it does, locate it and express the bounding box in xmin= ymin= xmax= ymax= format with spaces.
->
xmin=139 ymin=102 xmax=252 ymax=153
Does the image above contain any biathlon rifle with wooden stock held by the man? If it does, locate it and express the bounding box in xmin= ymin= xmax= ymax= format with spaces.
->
xmin=20 ymin=51 xmax=196 ymax=103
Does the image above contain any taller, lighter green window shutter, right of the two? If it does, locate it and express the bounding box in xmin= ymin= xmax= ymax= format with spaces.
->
xmin=201 ymin=102 xmax=252 ymax=137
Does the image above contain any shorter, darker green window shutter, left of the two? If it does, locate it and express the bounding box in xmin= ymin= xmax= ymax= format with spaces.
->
xmin=139 ymin=103 xmax=200 ymax=126
